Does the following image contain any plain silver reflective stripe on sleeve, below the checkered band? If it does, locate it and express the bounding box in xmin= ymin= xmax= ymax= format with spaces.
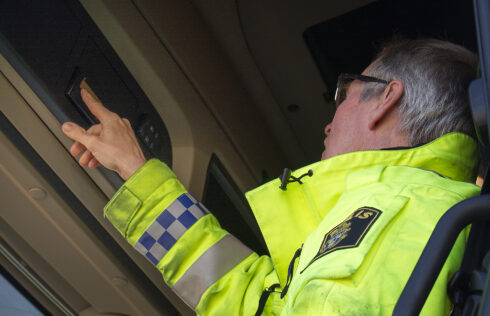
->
xmin=172 ymin=235 xmax=252 ymax=309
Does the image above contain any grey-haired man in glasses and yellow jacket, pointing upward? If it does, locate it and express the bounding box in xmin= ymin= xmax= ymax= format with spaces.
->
xmin=63 ymin=40 xmax=479 ymax=315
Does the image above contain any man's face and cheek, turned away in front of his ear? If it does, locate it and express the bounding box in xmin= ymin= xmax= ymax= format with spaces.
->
xmin=322 ymin=80 xmax=370 ymax=160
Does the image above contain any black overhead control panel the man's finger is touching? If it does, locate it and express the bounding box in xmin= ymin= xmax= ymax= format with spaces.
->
xmin=0 ymin=0 xmax=172 ymax=180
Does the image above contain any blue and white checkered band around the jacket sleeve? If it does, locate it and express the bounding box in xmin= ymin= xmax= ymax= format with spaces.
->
xmin=134 ymin=193 xmax=209 ymax=265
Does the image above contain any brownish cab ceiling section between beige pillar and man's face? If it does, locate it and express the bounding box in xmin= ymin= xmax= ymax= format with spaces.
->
xmin=191 ymin=0 xmax=372 ymax=167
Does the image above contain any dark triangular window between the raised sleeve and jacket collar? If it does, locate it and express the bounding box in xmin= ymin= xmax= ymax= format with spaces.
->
xmin=202 ymin=155 xmax=267 ymax=255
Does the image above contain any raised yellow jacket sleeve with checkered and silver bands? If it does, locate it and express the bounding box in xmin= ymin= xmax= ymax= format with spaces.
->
xmin=104 ymin=160 xmax=283 ymax=315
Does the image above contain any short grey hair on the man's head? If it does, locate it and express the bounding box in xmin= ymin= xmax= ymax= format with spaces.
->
xmin=360 ymin=39 xmax=478 ymax=146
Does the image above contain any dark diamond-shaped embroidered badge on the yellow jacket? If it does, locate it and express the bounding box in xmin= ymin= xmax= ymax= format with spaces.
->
xmin=303 ymin=206 xmax=382 ymax=271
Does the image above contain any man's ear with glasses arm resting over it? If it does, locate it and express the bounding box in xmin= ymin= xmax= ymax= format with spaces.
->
xmin=368 ymin=80 xmax=404 ymax=130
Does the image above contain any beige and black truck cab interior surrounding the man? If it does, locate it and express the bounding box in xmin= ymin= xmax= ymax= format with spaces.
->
xmin=0 ymin=0 xmax=490 ymax=316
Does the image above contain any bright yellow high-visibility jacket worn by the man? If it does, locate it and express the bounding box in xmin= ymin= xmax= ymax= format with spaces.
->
xmin=105 ymin=133 xmax=479 ymax=315
